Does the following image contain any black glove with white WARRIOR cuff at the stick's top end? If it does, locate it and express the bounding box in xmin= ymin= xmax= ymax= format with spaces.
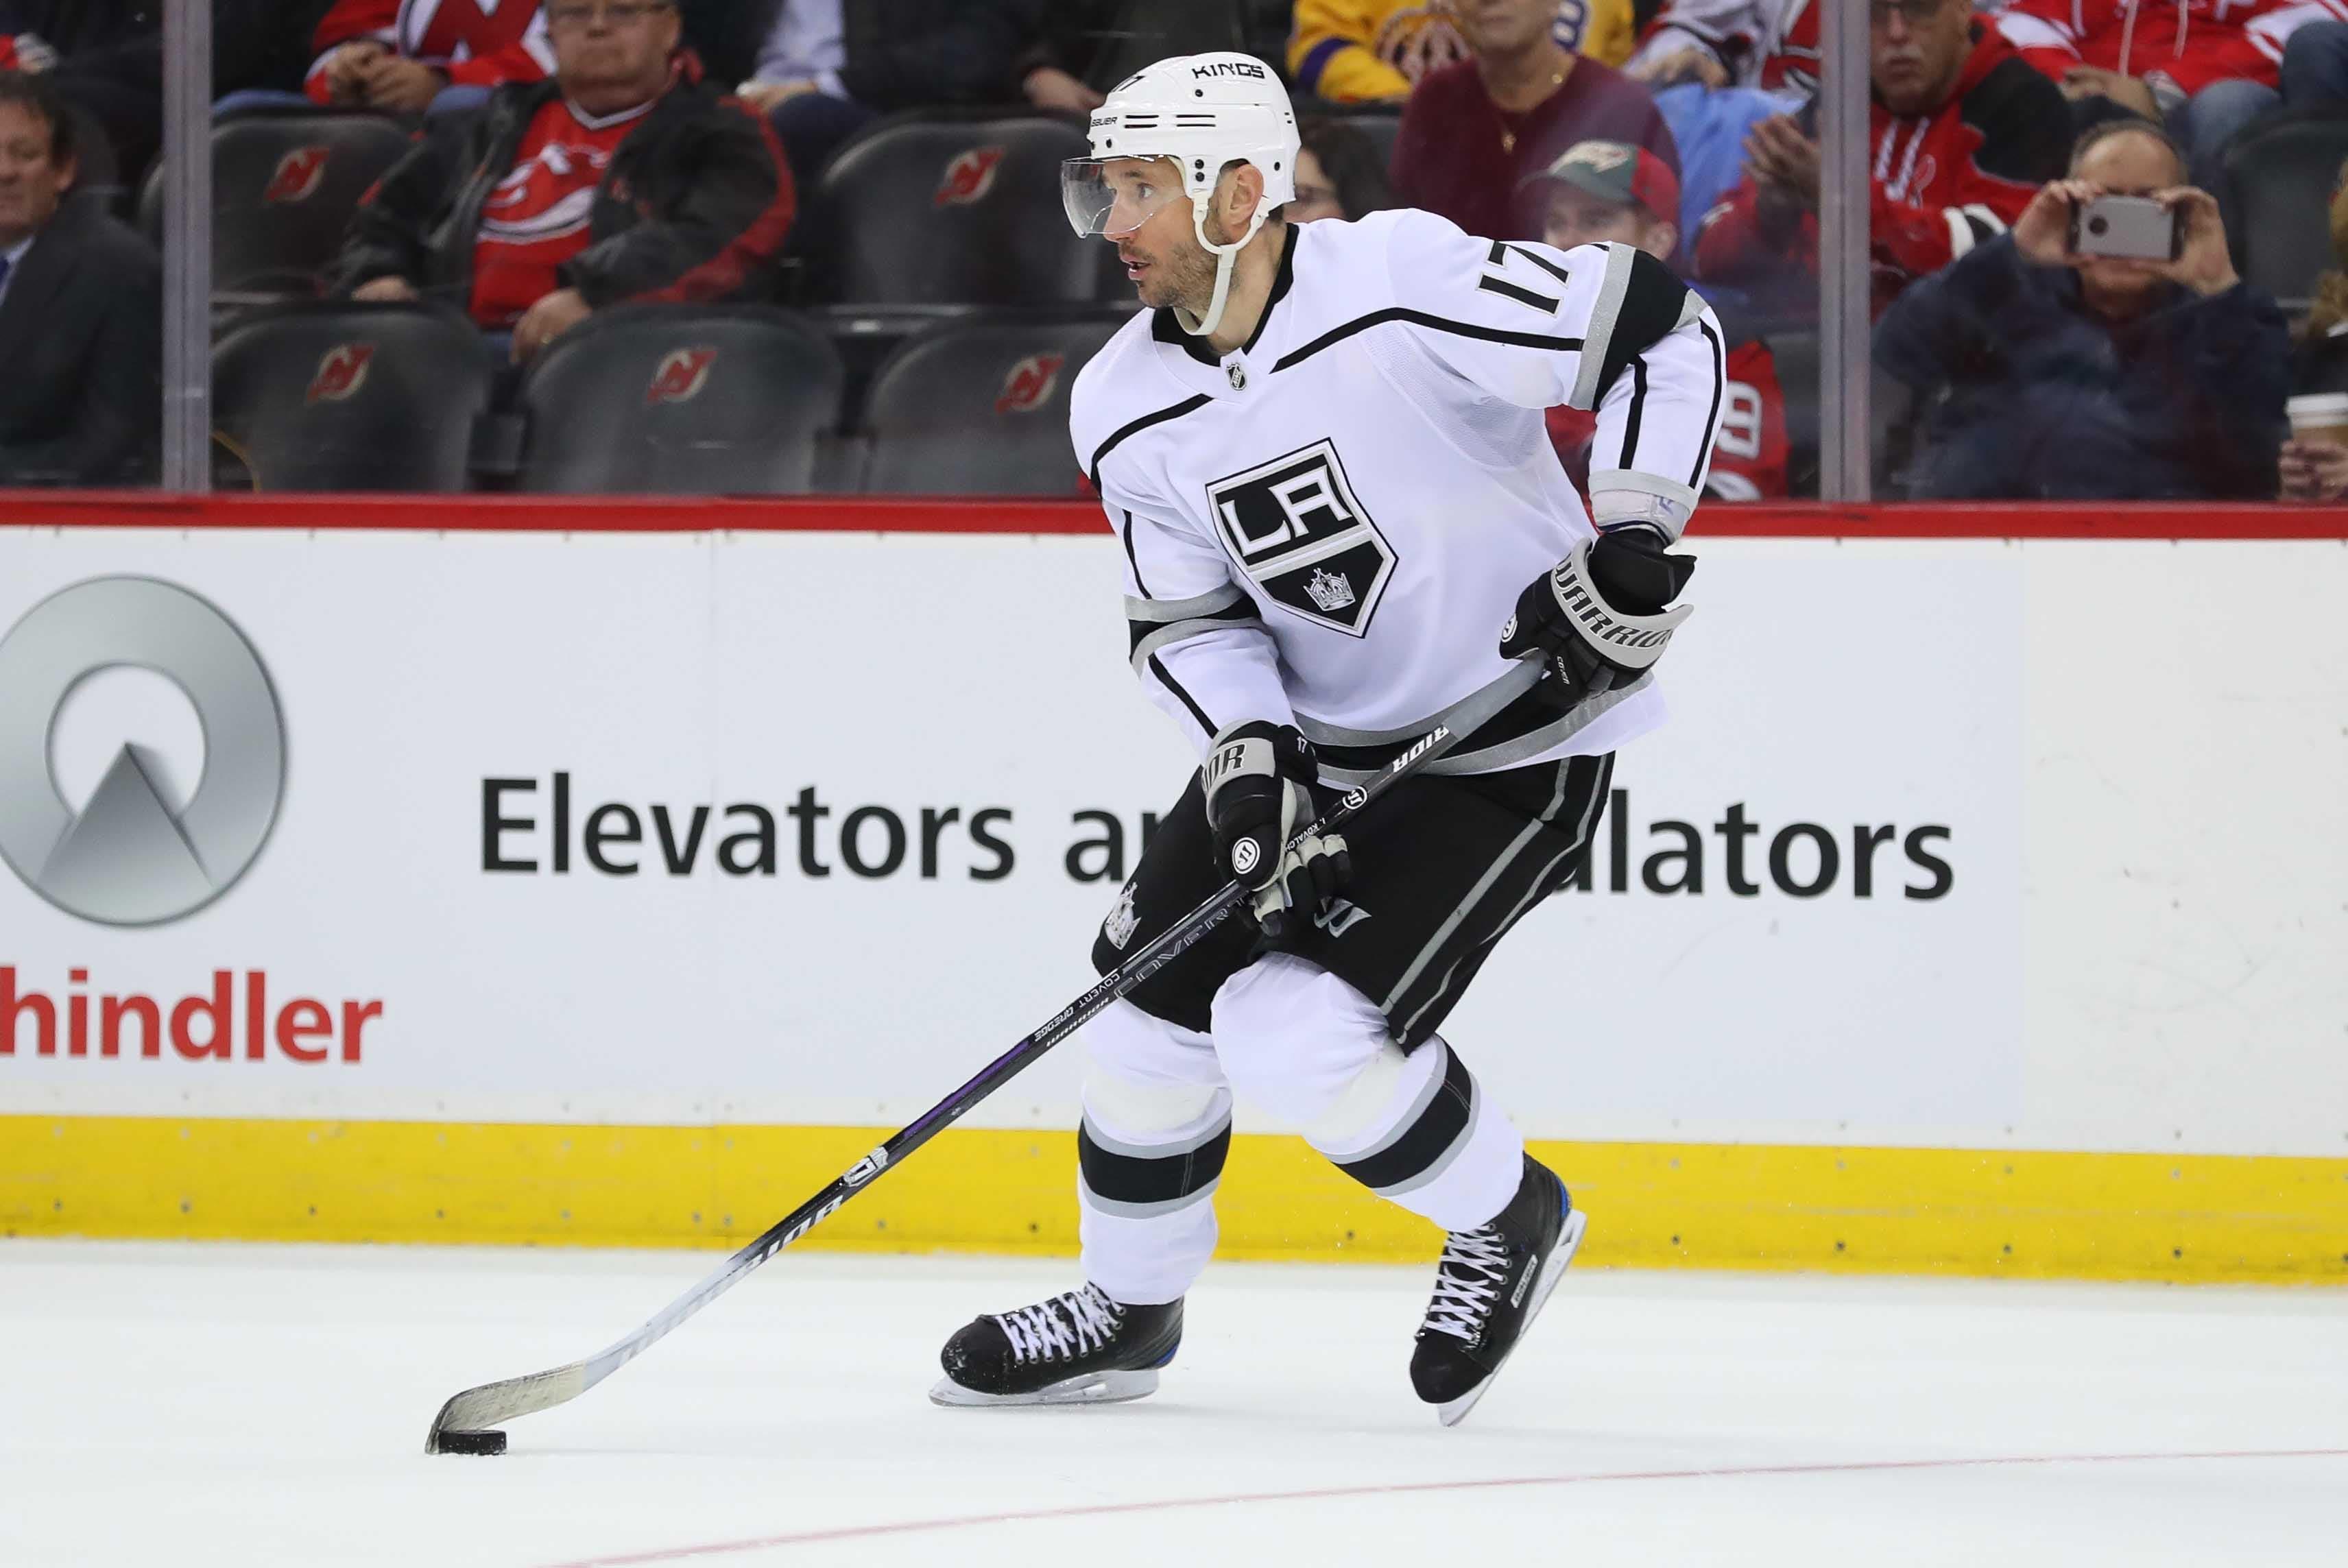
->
xmin=1500 ymin=523 xmax=1695 ymax=707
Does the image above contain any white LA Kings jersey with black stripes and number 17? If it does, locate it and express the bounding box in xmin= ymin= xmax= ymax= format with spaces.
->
xmin=1068 ymin=211 xmax=1726 ymax=784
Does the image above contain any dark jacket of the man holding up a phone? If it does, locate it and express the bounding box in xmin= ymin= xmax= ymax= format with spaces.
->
xmin=1873 ymin=234 xmax=2292 ymax=500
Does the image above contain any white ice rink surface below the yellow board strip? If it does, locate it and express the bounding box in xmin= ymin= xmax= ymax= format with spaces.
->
xmin=0 ymin=1242 xmax=2348 ymax=1568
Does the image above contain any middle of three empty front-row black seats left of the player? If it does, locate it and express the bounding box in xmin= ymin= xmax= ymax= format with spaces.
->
xmin=521 ymin=305 xmax=841 ymax=495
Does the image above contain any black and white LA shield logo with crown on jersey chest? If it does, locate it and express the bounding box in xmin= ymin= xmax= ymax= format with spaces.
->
xmin=1207 ymin=442 xmax=1395 ymax=636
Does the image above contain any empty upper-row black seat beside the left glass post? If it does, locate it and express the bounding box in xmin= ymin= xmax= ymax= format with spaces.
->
xmin=139 ymin=112 xmax=411 ymax=295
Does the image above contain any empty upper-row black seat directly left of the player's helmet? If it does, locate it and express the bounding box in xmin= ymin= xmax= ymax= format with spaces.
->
xmin=815 ymin=117 xmax=1103 ymax=305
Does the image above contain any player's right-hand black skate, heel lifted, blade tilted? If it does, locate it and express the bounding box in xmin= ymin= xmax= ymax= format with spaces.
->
xmin=1411 ymin=1155 xmax=1585 ymax=1427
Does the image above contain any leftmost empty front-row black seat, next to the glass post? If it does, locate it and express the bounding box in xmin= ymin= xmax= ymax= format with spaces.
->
xmin=211 ymin=303 xmax=495 ymax=491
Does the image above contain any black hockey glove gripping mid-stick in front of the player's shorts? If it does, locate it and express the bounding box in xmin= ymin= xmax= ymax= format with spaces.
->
xmin=1200 ymin=719 xmax=1352 ymax=941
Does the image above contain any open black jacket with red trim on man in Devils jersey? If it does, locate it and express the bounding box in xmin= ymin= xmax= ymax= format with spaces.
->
xmin=333 ymin=68 xmax=793 ymax=310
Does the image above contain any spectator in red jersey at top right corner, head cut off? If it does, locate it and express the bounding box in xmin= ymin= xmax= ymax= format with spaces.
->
xmin=1998 ymin=0 xmax=2348 ymax=185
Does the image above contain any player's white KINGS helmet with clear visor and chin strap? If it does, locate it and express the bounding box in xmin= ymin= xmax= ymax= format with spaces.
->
xmin=1059 ymin=51 xmax=1298 ymax=336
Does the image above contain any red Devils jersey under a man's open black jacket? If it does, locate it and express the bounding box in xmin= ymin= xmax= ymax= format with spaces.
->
xmin=472 ymin=99 xmax=653 ymax=326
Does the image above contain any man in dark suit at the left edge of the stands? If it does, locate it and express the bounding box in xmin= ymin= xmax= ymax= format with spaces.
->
xmin=0 ymin=71 xmax=162 ymax=483
